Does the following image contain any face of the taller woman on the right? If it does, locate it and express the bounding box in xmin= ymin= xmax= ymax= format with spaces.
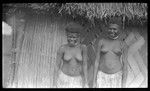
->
xmin=107 ymin=25 xmax=119 ymax=39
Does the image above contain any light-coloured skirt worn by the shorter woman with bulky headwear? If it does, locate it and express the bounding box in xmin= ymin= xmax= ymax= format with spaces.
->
xmin=57 ymin=71 xmax=82 ymax=88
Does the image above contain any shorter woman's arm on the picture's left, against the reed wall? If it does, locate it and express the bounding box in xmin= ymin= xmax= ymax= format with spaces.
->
xmin=53 ymin=46 xmax=64 ymax=86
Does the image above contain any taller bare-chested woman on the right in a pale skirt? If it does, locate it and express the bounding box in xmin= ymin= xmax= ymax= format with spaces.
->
xmin=93 ymin=24 xmax=127 ymax=88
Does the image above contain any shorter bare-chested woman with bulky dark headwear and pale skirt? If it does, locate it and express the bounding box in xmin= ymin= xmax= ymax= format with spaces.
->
xmin=54 ymin=22 xmax=87 ymax=88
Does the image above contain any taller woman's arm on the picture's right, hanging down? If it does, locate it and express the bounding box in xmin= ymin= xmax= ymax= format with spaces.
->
xmin=122 ymin=43 xmax=128 ymax=88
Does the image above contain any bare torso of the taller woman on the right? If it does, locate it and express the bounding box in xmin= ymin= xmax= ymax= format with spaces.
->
xmin=99 ymin=40 xmax=122 ymax=74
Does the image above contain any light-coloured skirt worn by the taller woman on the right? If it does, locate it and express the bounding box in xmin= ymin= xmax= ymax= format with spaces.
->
xmin=97 ymin=71 xmax=122 ymax=88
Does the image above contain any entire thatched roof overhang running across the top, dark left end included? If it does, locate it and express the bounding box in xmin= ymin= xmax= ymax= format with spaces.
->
xmin=3 ymin=3 xmax=148 ymax=25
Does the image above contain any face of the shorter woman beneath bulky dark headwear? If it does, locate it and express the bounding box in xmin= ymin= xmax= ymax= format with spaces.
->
xmin=67 ymin=33 xmax=79 ymax=46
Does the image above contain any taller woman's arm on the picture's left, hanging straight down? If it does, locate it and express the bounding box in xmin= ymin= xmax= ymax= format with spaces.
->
xmin=93 ymin=40 xmax=102 ymax=87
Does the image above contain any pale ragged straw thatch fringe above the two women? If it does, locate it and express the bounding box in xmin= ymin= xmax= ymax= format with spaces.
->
xmin=61 ymin=3 xmax=147 ymax=19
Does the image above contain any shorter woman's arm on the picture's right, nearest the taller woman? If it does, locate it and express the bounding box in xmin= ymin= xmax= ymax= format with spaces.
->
xmin=82 ymin=45 xmax=88 ymax=86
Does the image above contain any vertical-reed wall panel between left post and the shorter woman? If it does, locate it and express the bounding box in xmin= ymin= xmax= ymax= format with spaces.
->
xmin=11 ymin=16 xmax=66 ymax=88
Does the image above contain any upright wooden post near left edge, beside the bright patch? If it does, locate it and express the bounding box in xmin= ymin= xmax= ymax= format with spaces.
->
xmin=9 ymin=11 xmax=25 ymax=86
